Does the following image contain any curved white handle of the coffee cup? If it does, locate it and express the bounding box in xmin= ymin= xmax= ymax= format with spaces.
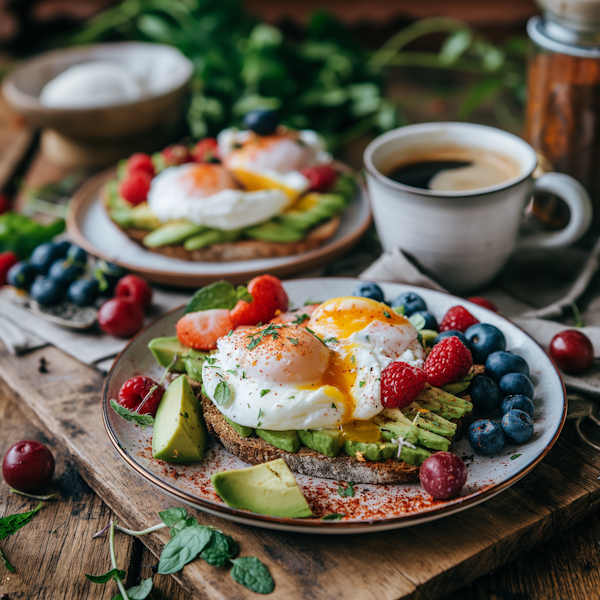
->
xmin=516 ymin=173 xmax=593 ymax=250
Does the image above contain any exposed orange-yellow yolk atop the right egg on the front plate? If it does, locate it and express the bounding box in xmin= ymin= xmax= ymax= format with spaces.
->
xmin=308 ymin=296 xmax=410 ymax=339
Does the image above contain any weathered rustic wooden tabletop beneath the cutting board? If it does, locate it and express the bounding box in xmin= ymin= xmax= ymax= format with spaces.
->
xmin=0 ymin=99 xmax=600 ymax=600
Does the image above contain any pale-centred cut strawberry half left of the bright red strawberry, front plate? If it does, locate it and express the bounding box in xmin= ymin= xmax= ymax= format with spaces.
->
xmin=175 ymin=308 xmax=234 ymax=350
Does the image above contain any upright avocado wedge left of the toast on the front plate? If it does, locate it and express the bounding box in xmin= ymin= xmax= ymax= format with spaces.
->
xmin=152 ymin=375 xmax=208 ymax=463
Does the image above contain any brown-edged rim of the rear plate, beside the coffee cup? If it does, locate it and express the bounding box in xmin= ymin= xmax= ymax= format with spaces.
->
xmin=66 ymin=161 xmax=373 ymax=287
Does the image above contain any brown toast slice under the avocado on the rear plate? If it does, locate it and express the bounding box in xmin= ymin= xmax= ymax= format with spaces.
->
xmin=115 ymin=214 xmax=341 ymax=262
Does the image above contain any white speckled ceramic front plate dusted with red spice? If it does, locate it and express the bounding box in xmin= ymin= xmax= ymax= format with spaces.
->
xmin=103 ymin=278 xmax=567 ymax=533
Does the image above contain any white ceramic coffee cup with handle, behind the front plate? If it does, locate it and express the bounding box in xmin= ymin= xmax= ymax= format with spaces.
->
xmin=364 ymin=123 xmax=592 ymax=292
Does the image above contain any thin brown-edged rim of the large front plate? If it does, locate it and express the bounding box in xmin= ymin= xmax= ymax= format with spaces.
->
xmin=102 ymin=277 xmax=568 ymax=533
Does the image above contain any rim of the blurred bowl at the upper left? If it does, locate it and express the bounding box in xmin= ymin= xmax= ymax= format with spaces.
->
xmin=2 ymin=42 xmax=194 ymax=115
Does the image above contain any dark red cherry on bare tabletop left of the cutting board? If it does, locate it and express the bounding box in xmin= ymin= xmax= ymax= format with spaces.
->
xmin=2 ymin=440 xmax=54 ymax=492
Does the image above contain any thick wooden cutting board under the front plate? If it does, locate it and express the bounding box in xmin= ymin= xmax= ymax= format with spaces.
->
xmin=0 ymin=346 xmax=600 ymax=600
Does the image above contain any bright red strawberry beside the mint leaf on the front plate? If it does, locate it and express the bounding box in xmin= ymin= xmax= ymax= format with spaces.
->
xmin=231 ymin=275 xmax=288 ymax=327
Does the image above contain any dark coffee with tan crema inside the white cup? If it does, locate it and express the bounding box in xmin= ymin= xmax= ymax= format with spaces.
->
xmin=387 ymin=146 xmax=519 ymax=192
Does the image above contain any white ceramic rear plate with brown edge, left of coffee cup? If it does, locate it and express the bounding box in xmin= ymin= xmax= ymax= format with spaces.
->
xmin=67 ymin=166 xmax=371 ymax=288
